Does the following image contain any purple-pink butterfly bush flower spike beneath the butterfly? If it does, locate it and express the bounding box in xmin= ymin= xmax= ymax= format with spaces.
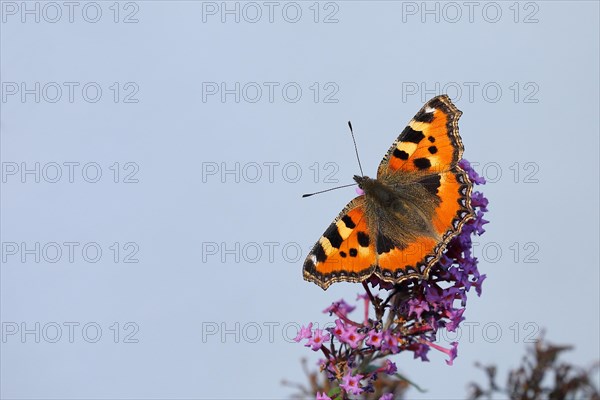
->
xmin=295 ymin=160 xmax=488 ymax=400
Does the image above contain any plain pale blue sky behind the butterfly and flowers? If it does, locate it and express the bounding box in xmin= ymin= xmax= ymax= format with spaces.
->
xmin=0 ymin=1 xmax=600 ymax=399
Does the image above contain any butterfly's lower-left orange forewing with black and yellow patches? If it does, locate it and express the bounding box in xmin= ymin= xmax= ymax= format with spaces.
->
xmin=303 ymin=196 xmax=376 ymax=289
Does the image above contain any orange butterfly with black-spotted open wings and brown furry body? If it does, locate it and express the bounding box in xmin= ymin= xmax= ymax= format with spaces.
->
xmin=303 ymin=95 xmax=474 ymax=290
